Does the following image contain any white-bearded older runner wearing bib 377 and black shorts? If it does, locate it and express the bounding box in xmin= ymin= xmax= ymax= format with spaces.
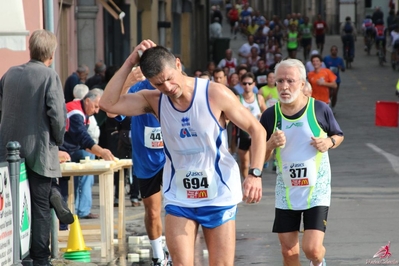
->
xmin=261 ymin=59 xmax=344 ymax=266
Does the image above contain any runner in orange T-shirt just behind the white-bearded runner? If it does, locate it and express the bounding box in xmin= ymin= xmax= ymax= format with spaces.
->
xmin=308 ymin=54 xmax=337 ymax=104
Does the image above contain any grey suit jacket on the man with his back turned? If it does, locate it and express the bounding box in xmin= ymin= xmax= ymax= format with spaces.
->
xmin=0 ymin=60 xmax=66 ymax=177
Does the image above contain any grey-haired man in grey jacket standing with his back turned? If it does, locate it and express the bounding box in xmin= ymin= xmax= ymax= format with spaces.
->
xmin=0 ymin=30 xmax=66 ymax=266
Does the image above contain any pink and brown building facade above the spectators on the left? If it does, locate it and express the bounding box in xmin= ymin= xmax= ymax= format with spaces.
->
xmin=0 ymin=0 xmax=209 ymax=82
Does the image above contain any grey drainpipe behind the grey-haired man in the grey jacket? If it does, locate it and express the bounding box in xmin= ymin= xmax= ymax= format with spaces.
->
xmin=44 ymin=0 xmax=58 ymax=258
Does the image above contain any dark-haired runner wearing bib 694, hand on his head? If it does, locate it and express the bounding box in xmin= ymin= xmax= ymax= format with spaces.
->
xmin=100 ymin=40 xmax=266 ymax=266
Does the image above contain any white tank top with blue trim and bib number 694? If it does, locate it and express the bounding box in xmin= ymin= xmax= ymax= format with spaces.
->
xmin=159 ymin=78 xmax=242 ymax=208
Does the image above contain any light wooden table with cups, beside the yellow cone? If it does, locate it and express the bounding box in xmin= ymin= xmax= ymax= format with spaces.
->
xmin=61 ymin=159 xmax=132 ymax=261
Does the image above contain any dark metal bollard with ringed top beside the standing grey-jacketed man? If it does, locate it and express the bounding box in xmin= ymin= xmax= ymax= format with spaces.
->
xmin=6 ymin=141 xmax=22 ymax=265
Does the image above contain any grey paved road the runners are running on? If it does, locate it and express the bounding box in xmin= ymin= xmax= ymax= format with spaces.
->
xmin=54 ymin=27 xmax=399 ymax=266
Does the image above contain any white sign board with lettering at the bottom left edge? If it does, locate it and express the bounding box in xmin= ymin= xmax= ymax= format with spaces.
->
xmin=0 ymin=163 xmax=14 ymax=266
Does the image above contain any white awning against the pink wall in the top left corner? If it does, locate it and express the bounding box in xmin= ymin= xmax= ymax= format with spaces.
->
xmin=0 ymin=0 xmax=29 ymax=51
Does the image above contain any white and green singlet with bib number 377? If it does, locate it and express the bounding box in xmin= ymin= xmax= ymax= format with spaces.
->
xmin=274 ymin=98 xmax=331 ymax=210
